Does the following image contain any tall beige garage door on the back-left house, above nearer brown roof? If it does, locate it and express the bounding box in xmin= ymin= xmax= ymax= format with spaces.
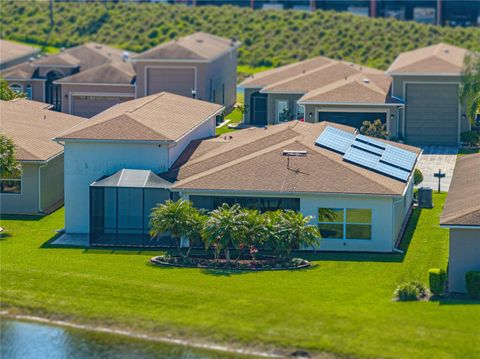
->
xmin=147 ymin=68 xmax=195 ymax=97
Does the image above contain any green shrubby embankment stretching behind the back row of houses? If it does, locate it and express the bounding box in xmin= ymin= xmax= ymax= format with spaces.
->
xmin=0 ymin=0 xmax=480 ymax=70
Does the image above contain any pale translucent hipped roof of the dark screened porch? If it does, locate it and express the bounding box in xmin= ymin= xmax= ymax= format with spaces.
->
xmin=90 ymin=168 xmax=172 ymax=189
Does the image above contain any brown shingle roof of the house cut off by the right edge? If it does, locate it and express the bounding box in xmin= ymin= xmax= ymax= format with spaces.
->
xmin=440 ymin=154 xmax=480 ymax=226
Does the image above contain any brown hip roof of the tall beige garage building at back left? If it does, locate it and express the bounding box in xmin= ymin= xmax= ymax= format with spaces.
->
xmin=132 ymin=32 xmax=239 ymax=60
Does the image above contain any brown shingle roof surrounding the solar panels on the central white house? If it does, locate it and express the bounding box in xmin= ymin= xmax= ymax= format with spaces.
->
xmin=166 ymin=121 xmax=420 ymax=195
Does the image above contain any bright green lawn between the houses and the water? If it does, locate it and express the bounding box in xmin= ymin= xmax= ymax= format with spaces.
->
xmin=0 ymin=194 xmax=480 ymax=358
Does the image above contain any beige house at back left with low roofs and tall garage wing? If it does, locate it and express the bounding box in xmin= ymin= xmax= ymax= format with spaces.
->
xmin=0 ymin=33 xmax=239 ymax=118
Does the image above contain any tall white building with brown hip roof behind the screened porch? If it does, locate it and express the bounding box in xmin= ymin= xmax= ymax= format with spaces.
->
xmin=55 ymin=92 xmax=224 ymax=233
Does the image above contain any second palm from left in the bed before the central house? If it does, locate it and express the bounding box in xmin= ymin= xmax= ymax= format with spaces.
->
xmin=203 ymin=203 xmax=245 ymax=265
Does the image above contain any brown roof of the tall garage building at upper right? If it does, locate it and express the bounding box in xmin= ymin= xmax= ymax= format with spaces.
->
xmin=387 ymin=43 xmax=468 ymax=75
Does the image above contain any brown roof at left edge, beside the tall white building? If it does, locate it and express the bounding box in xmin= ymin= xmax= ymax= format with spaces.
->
xmin=0 ymin=100 xmax=85 ymax=161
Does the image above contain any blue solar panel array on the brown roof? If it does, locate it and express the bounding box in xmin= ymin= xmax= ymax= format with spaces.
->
xmin=315 ymin=126 xmax=417 ymax=182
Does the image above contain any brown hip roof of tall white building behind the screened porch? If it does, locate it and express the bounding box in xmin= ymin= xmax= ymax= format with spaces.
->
xmin=57 ymin=92 xmax=223 ymax=141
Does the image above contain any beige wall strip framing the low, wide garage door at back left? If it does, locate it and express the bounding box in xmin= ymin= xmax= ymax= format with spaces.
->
xmin=60 ymin=84 xmax=135 ymax=113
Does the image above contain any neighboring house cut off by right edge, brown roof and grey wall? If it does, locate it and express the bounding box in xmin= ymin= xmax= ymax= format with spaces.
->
xmin=440 ymin=154 xmax=480 ymax=293
